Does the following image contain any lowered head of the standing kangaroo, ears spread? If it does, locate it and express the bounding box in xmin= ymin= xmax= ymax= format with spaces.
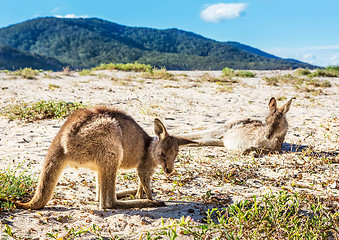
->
xmin=153 ymin=118 xmax=196 ymax=174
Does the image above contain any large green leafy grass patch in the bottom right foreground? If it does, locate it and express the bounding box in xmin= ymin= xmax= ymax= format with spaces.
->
xmin=146 ymin=191 xmax=339 ymax=239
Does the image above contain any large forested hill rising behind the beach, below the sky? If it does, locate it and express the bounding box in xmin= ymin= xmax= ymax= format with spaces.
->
xmin=0 ymin=17 xmax=314 ymax=70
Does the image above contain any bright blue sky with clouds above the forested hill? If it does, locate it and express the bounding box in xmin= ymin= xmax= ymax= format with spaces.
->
xmin=0 ymin=0 xmax=339 ymax=66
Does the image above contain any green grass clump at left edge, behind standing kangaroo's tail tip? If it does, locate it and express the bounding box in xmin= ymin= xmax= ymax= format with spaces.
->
xmin=0 ymin=167 xmax=36 ymax=212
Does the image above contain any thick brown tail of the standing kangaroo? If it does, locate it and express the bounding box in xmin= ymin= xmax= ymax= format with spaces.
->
xmin=13 ymin=144 xmax=67 ymax=209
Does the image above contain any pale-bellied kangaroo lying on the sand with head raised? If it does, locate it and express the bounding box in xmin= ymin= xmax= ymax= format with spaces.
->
xmin=179 ymin=97 xmax=292 ymax=154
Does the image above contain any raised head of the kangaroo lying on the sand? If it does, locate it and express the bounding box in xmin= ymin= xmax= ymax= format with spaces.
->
xmin=265 ymin=97 xmax=292 ymax=140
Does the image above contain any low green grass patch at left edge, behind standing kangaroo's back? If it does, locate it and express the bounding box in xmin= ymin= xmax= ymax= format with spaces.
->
xmin=0 ymin=100 xmax=86 ymax=122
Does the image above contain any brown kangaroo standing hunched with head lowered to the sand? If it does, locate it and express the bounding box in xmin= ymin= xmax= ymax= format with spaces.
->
xmin=5 ymin=106 xmax=194 ymax=209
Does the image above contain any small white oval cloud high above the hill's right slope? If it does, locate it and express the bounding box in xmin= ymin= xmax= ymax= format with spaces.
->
xmin=200 ymin=3 xmax=248 ymax=23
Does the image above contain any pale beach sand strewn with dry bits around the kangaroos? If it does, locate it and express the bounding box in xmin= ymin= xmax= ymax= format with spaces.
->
xmin=0 ymin=68 xmax=339 ymax=239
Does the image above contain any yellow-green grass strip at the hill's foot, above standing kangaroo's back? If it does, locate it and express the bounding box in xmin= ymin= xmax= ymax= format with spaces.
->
xmin=93 ymin=63 xmax=153 ymax=73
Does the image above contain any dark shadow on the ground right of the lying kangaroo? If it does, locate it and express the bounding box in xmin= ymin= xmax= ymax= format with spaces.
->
xmin=281 ymin=143 xmax=339 ymax=157
